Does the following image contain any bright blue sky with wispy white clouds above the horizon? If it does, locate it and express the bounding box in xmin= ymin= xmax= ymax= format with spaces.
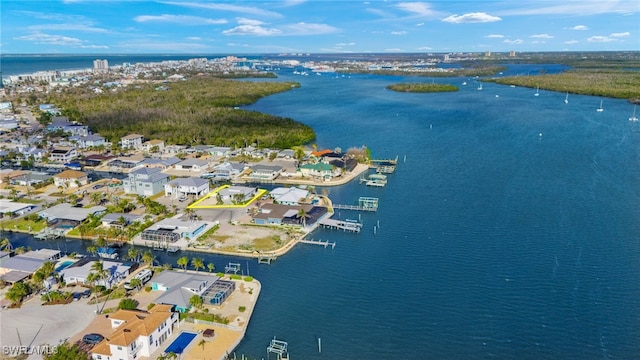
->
xmin=0 ymin=0 xmax=640 ymax=54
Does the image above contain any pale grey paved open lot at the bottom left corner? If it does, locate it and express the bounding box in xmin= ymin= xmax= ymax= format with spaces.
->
xmin=0 ymin=290 xmax=96 ymax=348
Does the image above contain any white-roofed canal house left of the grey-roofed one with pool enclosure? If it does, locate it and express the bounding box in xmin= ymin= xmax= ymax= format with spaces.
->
xmin=60 ymin=257 xmax=138 ymax=289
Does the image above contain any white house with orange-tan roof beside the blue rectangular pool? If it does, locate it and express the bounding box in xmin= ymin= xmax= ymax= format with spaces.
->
xmin=90 ymin=304 xmax=179 ymax=360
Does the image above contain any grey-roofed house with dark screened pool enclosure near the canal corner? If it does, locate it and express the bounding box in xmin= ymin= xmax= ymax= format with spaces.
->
xmin=151 ymin=270 xmax=235 ymax=312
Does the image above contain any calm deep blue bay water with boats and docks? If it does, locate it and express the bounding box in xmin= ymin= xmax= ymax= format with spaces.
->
xmin=2 ymin=57 xmax=640 ymax=359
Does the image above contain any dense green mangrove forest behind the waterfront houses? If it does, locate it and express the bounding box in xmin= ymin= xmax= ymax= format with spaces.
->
xmin=48 ymin=76 xmax=315 ymax=148
